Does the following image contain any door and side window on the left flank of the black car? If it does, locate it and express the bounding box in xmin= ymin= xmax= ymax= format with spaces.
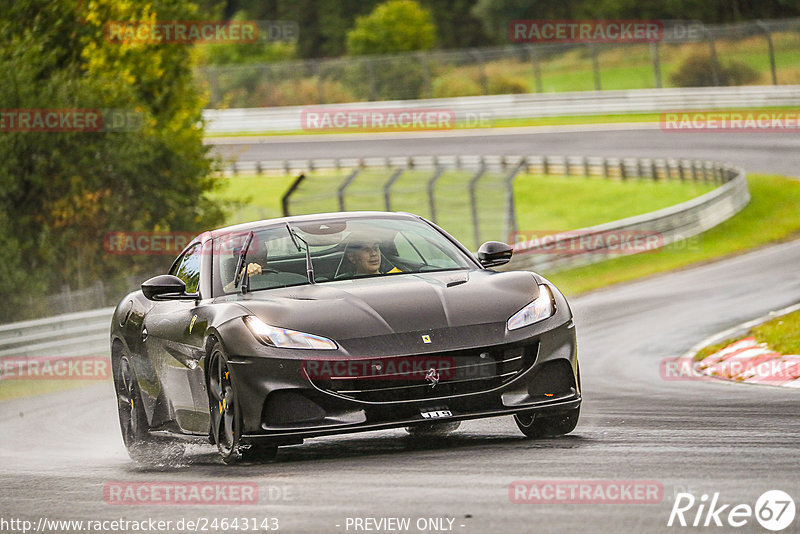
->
xmin=143 ymin=243 xmax=208 ymax=433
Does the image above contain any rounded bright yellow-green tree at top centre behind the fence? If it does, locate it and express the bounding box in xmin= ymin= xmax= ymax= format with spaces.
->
xmin=347 ymin=0 xmax=436 ymax=56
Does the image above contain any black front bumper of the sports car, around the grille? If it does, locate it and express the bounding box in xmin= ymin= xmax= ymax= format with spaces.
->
xmin=229 ymin=319 xmax=581 ymax=444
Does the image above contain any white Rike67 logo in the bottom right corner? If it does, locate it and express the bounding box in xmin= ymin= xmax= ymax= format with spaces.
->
xmin=667 ymin=490 xmax=797 ymax=532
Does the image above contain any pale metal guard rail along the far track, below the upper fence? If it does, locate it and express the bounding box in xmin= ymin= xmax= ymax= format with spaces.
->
xmin=203 ymin=85 xmax=800 ymax=136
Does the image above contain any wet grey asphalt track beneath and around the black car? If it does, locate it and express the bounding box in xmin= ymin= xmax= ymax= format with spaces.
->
xmin=0 ymin=127 xmax=800 ymax=533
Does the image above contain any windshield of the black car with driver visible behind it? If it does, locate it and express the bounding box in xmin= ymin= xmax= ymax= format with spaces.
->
xmin=213 ymin=217 xmax=475 ymax=295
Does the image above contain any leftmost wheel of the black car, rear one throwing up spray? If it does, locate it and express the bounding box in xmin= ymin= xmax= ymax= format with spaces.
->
xmin=114 ymin=355 xmax=186 ymax=467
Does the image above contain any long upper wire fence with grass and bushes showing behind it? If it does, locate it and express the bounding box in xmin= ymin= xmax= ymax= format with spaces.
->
xmin=198 ymin=19 xmax=800 ymax=108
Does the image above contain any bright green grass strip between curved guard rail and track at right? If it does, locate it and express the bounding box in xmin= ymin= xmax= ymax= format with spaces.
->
xmin=543 ymin=174 xmax=800 ymax=295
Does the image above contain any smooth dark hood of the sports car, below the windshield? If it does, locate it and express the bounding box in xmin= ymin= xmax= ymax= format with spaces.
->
xmin=240 ymin=270 xmax=538 ymax=339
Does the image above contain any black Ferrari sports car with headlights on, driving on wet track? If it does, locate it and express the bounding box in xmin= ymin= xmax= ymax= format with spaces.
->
xmin=111 ymin=212 xmax=581 ymax=463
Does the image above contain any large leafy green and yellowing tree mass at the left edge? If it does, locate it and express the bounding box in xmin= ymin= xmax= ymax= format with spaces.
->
xmin=0 ymin=0 xmax=223 ymax=320
